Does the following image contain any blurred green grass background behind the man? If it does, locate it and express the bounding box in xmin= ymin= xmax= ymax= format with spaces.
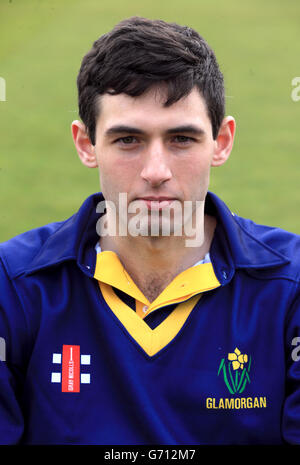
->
xmin=0 ymin=0 xmax=300 ymax=241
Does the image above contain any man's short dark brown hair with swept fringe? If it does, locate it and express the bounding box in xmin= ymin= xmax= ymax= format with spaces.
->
xmin=77 ymin=16 xmax=225 ymax=145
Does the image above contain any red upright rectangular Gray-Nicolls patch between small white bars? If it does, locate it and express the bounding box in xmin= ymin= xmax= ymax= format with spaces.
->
xmin=61 ymin=345 xmax=80 ymax=392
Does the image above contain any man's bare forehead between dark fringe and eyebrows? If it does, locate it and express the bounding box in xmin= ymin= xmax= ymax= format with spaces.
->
xmin=97 ymin=87 xmax=211 ymax=132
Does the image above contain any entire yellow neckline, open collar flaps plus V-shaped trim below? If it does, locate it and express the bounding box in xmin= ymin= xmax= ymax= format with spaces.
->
xmin=94 ymin=251 xmax=221 ymax=356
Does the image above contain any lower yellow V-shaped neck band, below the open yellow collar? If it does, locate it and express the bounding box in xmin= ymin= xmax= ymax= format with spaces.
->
xmin=99 ymin=281 xmax=201 ymax=357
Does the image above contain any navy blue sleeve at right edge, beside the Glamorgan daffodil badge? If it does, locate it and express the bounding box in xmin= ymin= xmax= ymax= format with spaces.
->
xmin=282 ymin=287 xmax=300 ymax=445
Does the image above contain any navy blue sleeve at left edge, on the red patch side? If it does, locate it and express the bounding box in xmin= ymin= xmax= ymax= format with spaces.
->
xmin=0 ymin=259 xmax=28 ymax=444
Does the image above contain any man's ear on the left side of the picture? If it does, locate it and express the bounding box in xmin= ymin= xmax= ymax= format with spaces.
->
xmin=71 ymin=120 xmax=98 ymax=168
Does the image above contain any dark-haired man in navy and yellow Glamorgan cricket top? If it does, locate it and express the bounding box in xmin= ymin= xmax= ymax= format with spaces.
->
xmin=0 ymin=17 xmax=300 ymax=445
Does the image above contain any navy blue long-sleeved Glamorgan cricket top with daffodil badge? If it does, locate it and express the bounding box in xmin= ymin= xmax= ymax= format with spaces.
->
xmin=0 ymin=193 xmax=300 ymax=445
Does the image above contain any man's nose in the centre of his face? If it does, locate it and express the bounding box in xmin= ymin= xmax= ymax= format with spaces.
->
xmin=141 ymin=141 xmax=172 ymax=187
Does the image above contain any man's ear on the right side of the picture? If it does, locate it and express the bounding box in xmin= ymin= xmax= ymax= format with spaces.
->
xmin=211 ymin=116 xmax=236 ymax=166
